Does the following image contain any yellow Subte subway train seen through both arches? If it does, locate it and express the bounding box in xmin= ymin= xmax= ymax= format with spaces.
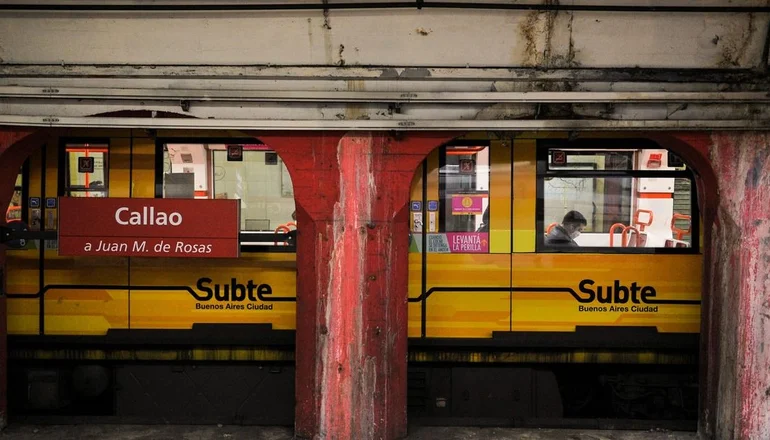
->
xmin=5 ymin=129 xmax=703 ymax=429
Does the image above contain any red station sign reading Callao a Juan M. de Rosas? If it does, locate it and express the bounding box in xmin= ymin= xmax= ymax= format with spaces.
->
xmin=59 ymin=197 xmax=240 ymax=258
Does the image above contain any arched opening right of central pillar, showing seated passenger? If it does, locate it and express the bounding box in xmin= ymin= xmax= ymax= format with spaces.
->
xmin=402 ymin=133 xmax=716 ymax=430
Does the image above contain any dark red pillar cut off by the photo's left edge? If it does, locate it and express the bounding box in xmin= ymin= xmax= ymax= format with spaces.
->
xmin=0 ymin=127 xmax=47 ymax=429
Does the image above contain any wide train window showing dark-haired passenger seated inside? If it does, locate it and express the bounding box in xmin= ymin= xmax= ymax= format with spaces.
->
xmin=538 ymin=148 xmax=697 ymax=252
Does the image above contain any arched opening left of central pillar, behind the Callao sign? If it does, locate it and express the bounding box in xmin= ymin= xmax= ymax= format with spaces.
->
xmin=0 ymin=129 xmax=296 ymax=425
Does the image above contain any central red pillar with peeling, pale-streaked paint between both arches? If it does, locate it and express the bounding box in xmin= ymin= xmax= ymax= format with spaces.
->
xmin=254 ymin=132 xmax=456 ymax=440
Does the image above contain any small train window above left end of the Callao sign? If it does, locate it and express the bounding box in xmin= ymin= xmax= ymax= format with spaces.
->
xmin=63 ymin=143 xmax=109 ymax=197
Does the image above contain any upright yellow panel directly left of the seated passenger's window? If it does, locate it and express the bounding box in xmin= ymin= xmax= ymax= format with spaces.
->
xmin=513 ymin=139 xmax=537 ymax=252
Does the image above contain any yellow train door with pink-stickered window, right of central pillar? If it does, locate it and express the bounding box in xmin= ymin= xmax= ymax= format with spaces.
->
xmin=409 ymin=140 xmax=511 ymax=339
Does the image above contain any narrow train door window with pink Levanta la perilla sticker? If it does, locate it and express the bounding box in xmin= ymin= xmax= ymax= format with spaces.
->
xmin=438 ymin=145 xmax=490 ymax=253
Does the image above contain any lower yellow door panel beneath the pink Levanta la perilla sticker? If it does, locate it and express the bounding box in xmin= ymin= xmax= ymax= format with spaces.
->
xmin=426 ymin=254 xmax=511 ymax=338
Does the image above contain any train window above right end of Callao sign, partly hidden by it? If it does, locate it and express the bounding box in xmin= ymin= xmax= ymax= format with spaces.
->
xmin=162 ymin=143 xmax=296 ymax=245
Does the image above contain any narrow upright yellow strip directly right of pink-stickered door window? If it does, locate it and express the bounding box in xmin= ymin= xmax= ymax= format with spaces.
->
xmin=489 ymin=141 xmax=511 ymax=254
